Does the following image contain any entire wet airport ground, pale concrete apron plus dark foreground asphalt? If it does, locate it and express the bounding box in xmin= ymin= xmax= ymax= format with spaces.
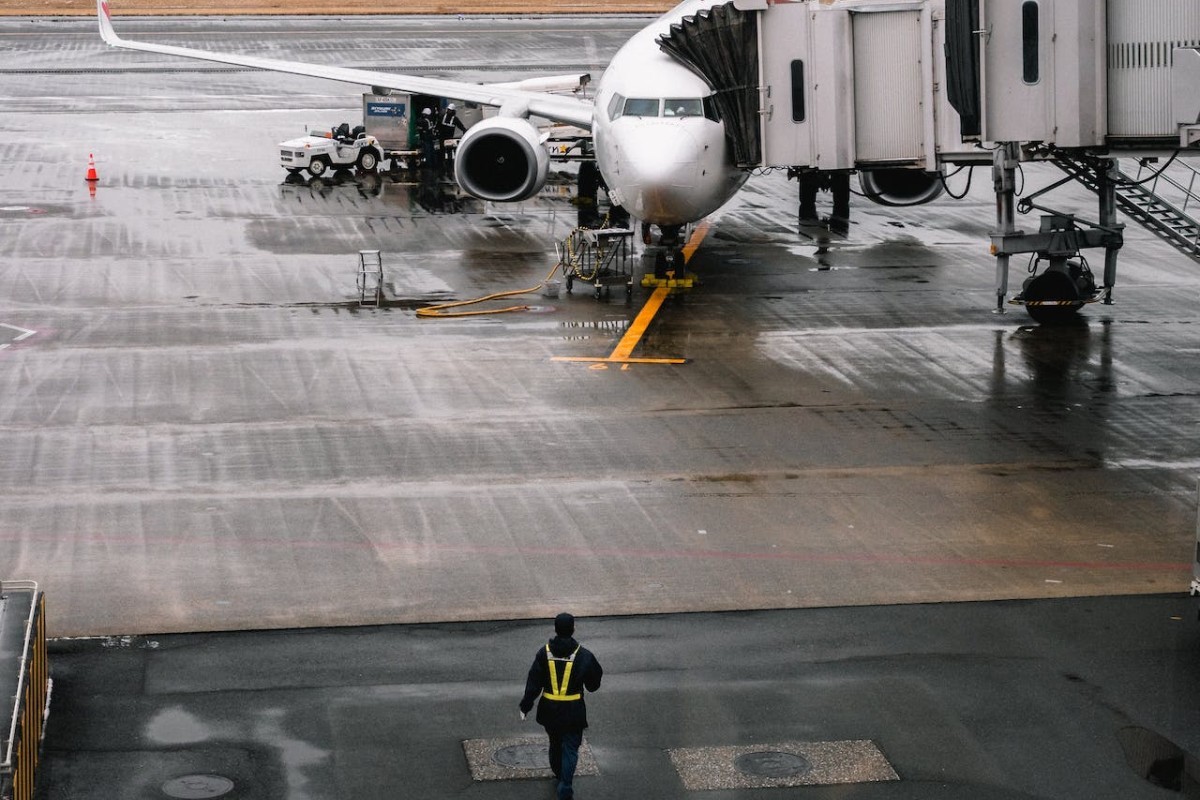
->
xmin=0 ymin=18 xmax=1200 ymax=798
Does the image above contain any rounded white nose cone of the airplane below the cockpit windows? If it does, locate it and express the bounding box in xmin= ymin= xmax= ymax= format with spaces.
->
xmin=619 ymin=124 xmax=701 ymax=224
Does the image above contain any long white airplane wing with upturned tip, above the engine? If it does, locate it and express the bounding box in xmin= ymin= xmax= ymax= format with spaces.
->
xmin=96 ymin=0 xmax=592 ymax=130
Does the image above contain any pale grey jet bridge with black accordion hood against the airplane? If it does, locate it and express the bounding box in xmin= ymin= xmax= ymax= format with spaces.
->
xmin=659 ymin=0 xmax=1200 ymax=321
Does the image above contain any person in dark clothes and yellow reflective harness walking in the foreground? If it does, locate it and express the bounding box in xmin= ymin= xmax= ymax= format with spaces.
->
xmin=521 ymin=612 xmax=604 ymax=800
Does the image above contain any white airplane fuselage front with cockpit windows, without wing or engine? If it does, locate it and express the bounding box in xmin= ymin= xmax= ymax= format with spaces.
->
xmin=592 ymin=0 xmax=746 ymax=225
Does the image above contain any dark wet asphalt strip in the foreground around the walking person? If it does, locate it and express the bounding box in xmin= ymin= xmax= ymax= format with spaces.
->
xmin=40 ymin=595 xmax=1200 ymax=800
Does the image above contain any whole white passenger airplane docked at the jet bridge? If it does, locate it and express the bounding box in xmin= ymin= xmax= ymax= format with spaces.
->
xmin=97 ymin=0 xmax=937 ymax=273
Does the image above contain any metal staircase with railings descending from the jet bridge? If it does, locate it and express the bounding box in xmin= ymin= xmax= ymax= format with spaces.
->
xmin=1051 ymin=151 xmax=1200 ymax=261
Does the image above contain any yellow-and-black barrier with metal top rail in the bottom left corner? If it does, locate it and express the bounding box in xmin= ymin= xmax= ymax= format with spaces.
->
xmin=0 ymin=581 xmax=50 ymax=800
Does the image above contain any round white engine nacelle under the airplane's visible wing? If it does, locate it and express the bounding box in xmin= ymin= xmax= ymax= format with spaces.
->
xmin=454 ymin=116 xmax=550 ymax=203
